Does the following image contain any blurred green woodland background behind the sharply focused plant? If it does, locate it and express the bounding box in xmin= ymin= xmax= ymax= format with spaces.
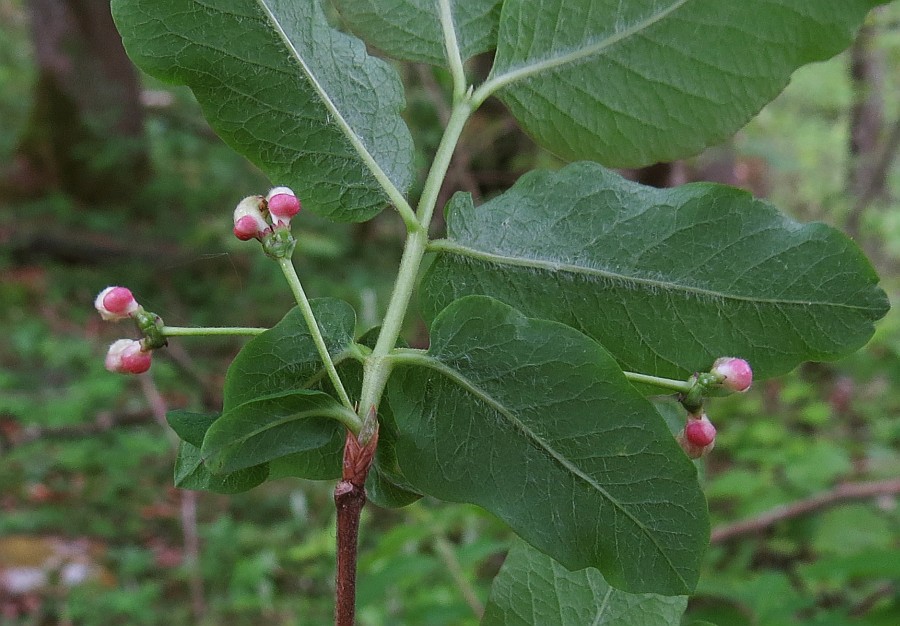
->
xmin=0 ymin=0 xmax=900 ymax=626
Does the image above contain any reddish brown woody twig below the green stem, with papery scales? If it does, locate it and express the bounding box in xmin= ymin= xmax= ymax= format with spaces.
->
xmin=334 ymin=407 xmax=378 ymax=626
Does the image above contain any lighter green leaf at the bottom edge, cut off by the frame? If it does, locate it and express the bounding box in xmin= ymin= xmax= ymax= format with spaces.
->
xmin=481 ymin=542 xmax=687 ymax=626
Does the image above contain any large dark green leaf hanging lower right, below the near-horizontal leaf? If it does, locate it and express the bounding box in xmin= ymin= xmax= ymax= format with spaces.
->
xmin=387 ymin=297 xmax=709 ymax=595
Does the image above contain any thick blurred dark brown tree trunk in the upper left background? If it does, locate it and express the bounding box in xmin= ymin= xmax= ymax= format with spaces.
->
xmin=11 ymin=0 xmax=148 ymax=203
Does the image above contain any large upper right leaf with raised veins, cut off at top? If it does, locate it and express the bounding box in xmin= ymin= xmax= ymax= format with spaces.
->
xmin=480 ymin=0 xmax=884 ymax=167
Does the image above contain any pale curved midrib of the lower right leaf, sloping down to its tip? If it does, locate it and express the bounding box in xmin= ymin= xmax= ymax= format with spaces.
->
xmin=390 ymin=352 xmax=690 ymax=588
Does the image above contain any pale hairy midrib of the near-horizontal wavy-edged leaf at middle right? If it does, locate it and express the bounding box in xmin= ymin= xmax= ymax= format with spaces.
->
xmin=428 ymin=239 xmax=871 ymax=311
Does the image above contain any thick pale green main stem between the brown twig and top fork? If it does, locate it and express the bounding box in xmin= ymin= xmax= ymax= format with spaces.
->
xmin=358 ymin=97 xmax=474 ymax=417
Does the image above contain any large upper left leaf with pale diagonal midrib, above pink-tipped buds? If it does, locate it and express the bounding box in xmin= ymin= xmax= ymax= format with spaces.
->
xmin=112 ymin=0 xmax=413 ymax=221
